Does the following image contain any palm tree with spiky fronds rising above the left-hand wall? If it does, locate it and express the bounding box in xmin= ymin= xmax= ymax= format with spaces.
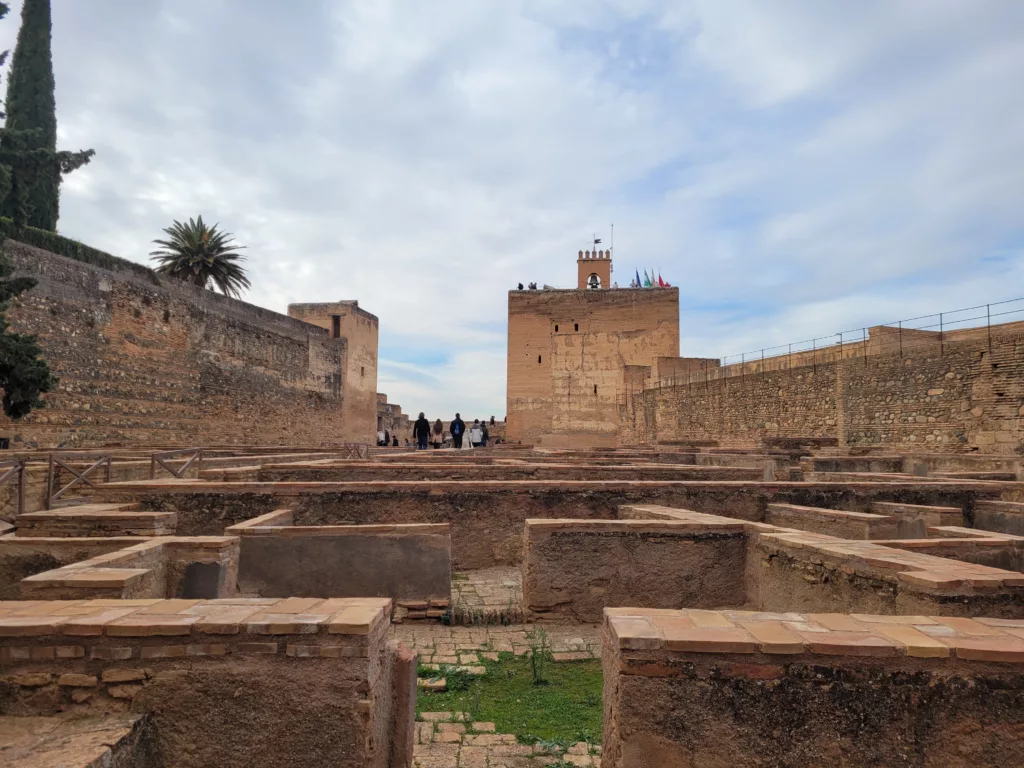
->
xmin=150 ymin=216 xmax=250 ymax=298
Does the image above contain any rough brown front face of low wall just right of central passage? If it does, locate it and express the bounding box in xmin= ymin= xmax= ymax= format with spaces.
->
xmin=522 ymin=520 xmax=746 ymax=623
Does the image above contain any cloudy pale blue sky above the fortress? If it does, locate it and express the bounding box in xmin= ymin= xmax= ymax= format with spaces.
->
xmin=0 ymin=0 xmax=1024 ymax=418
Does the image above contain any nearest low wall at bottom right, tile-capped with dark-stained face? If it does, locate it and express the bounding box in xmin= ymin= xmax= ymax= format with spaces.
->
xmin=601 ymin=608 xmax=1024 ymax=768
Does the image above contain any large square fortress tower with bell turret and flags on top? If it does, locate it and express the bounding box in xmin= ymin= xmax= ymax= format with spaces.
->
xmin=507 ymin=251 xmax=679 ymax=447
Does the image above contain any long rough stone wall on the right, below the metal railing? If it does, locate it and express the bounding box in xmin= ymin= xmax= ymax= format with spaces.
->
xmin=620 ymin=326 xmax=1024 ymax=454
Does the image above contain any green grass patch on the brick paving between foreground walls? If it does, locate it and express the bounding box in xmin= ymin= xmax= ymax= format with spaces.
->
xmin=416 ymin=653 xmax=603 ymax=743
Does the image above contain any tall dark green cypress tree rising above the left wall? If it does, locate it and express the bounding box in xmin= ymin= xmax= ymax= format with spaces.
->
xmin=0 ymin=0 xmax=93 ymax=231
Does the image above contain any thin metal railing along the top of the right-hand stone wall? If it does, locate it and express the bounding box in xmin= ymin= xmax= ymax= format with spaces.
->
xmin=632 ymin=298 xmax=1024 ymax=393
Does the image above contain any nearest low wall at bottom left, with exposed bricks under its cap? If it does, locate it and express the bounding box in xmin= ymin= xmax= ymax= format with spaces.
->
xmin=0 ymin=598 xmax=416 ymax=768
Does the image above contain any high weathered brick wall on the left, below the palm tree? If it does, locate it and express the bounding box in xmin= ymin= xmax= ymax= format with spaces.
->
xmin=0 ymin=240 xmax=349 ymax=447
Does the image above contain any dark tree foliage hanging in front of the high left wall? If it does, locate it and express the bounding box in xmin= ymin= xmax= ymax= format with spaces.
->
xmin=0 ymin=250 xmax=57 ymax=419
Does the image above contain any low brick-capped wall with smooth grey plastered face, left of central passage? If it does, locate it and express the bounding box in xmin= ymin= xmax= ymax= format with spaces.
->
xmin=228 ymin=511 xmax=452 ymax=611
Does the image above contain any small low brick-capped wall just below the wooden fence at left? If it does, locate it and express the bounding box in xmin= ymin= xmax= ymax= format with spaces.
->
xmin=14 ymin=504 xmax=177 ymax=539
